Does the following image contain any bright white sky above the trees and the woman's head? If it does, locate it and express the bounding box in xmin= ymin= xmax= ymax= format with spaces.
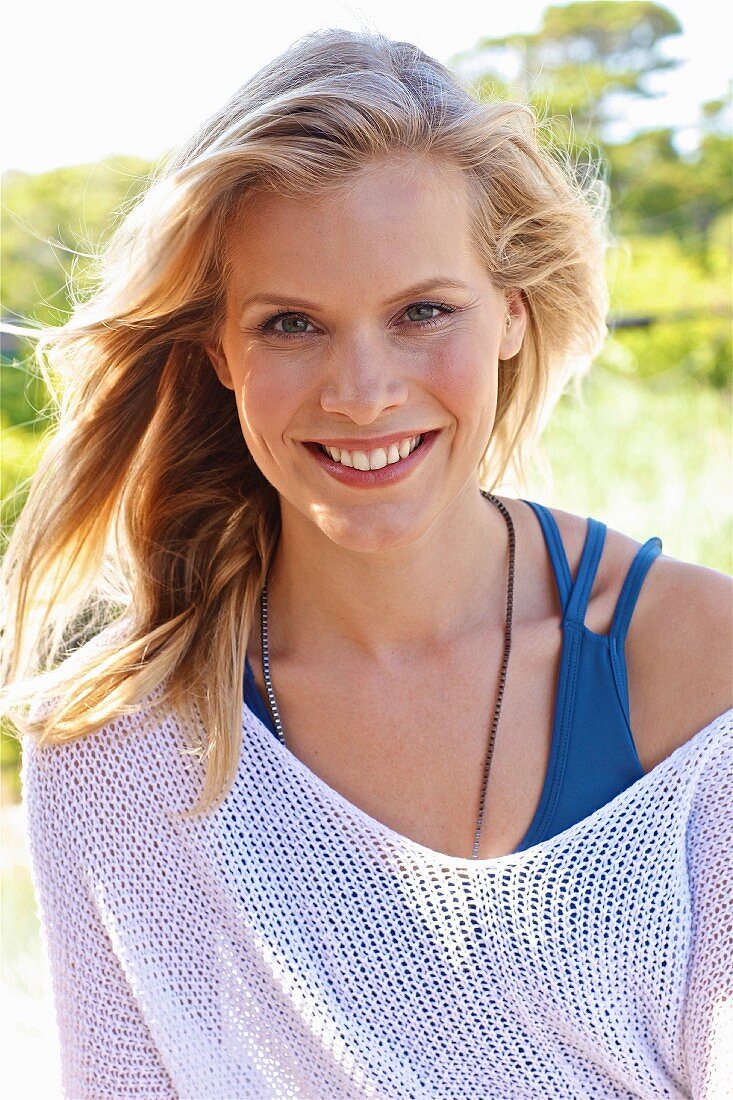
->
xmin=0 ymin=0 xmax=733 ymax=172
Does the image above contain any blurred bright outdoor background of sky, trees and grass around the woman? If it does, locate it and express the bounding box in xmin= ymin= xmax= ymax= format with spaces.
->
xmin=0 ymin=0 xmax=733 ymax=1098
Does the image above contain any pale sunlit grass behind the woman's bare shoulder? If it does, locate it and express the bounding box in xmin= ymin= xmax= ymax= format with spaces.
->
xmin=522 ymin=371 xmax=733 ymax=574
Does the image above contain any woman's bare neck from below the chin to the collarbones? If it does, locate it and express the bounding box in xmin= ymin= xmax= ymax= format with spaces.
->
xmin=267 ymin=485 xmax=508 ymax=663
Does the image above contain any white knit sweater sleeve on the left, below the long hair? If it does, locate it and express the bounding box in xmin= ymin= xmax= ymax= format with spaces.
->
xmin=22 ymin=738 xmax=176 ymax=1100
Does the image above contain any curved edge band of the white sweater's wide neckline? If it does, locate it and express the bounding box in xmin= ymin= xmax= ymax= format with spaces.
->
xmin=242 ymin=701 xmax=733 ymax=873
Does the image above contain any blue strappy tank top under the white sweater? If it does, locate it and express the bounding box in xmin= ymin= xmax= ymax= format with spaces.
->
xmin=244 ymin=501 xmax=661 ymax=851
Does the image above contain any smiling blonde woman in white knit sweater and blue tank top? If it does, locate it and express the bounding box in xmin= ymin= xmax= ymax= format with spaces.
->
xmin=6 ymin=23 xmax=733 ymax=1100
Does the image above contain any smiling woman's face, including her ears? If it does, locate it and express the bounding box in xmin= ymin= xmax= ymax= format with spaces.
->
xmin=208 ymin=157 xmax=526 ymax=551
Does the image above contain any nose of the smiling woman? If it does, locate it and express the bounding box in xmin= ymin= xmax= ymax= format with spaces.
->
xmin=320 ymin=343 xmax=408 ymax=424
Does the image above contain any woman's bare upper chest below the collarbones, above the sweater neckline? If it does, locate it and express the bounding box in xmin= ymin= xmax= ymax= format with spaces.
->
xmin=245 ymin=622 xmax=562 ymax=859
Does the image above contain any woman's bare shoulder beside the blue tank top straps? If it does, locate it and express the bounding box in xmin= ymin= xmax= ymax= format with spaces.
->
xmin=534 ymin=508 xmax=733 ymax=771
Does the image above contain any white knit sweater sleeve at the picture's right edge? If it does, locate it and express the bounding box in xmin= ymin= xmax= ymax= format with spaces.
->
xmin=683 ymin=711 xmax=733 ymax=1100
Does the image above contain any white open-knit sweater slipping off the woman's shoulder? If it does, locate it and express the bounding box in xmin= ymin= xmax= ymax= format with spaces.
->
xmin=23 ymin=688 xmax=733 ymax=1100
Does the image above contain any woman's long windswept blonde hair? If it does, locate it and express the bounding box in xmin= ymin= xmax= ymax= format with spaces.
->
xmin=2 ymin=29 xmax=608 ymax=816
